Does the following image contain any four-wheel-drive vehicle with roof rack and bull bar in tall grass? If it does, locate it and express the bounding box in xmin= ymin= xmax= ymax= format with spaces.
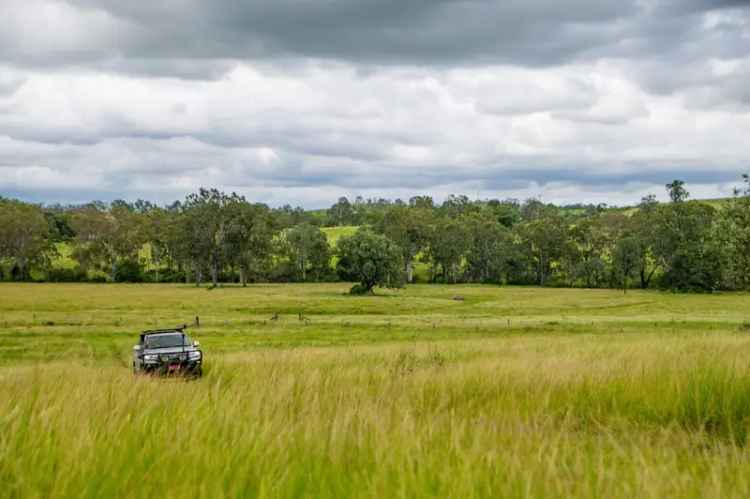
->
xmin=133 ymin=328 xmax=203 ymax=376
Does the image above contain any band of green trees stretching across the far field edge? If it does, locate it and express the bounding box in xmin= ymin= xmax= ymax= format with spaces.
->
xmin=0 ymin=175 xmax=750 ymax=293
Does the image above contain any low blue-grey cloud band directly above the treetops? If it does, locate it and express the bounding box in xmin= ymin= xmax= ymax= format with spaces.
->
xmin=0 ymin=146 xmax=739 ymax=204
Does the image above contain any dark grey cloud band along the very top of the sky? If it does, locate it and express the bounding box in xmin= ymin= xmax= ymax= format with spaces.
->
xmin=0 ymin=0 xmax=750 ymax=83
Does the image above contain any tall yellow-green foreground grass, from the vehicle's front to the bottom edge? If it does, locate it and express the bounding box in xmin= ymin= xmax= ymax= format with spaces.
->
xmin=0 ymin=335 xmax=750 ymax=497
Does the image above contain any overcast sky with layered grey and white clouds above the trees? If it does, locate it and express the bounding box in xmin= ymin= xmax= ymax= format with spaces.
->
xmin=0 ymin=0 xmax=750 ymax=208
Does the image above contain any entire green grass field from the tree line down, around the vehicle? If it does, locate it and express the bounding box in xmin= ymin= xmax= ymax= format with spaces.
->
xmin=0 ymin=284 xmax=750 ymax=498
